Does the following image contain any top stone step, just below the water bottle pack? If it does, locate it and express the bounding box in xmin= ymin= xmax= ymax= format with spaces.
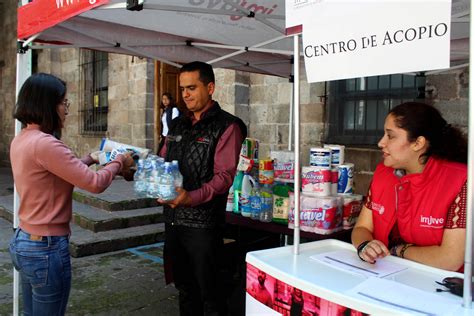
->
xmin=72 ymin=178 xmax=158 ymax=212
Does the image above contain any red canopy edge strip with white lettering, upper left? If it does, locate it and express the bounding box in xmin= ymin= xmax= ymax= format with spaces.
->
xmin=18 ymin=0 xmax=109 ymax=39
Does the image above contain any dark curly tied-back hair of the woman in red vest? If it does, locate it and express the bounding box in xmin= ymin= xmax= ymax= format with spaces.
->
xmin=389 ymin=102 xmax=467 ymax=163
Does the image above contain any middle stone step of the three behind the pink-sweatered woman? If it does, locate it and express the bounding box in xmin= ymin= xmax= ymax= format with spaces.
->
xmin=72 ymin=201 xmax=163 ymax=233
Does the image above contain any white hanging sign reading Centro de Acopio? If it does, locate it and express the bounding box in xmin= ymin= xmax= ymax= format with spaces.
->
xmin=302 ymin=0 xmax=451 ymax=82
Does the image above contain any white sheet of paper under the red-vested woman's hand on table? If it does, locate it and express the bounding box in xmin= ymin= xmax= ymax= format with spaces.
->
xmin=310 ymin=250 xmax=407 ymax=278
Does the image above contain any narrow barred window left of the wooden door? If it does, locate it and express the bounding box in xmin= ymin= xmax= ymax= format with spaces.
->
xmin=79 ymin=50 xmax=109 ymax=135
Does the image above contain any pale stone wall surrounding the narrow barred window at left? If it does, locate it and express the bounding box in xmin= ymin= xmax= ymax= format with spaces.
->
xmin=38 ymin=49 xmax=154 ymax=156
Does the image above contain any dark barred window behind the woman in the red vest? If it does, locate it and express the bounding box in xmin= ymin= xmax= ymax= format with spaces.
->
xmin=326 ymin=74 xmax=425 ymax=145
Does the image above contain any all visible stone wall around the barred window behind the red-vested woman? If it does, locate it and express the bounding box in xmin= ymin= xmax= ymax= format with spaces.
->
xmin=246 ymin=67 xmax=469 ymax=195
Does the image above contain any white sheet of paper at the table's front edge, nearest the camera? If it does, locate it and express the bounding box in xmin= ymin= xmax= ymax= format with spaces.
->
xmin=346 ymin=278 xmax=461 ymax=315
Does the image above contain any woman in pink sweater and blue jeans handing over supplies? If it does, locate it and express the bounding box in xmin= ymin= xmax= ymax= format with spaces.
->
xmin=9 ymin=73 xmax=133 ymax=316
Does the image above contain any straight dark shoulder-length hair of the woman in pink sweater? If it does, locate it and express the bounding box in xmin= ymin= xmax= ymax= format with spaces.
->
xmin=13 ymin=73 xmax=67 ymax=138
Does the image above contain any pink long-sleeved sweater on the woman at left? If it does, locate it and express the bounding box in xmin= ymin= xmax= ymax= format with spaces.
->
xmin=10 ymin=124 xmax=125 ymax=236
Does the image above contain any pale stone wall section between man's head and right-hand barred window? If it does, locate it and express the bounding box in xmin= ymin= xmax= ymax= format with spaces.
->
xmin=249 ymin=68 xmax=325 ymax=165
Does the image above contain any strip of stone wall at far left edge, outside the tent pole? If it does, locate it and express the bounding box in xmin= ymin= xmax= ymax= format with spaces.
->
xmin=0 ymin=1 xmax=17 ymax=166
